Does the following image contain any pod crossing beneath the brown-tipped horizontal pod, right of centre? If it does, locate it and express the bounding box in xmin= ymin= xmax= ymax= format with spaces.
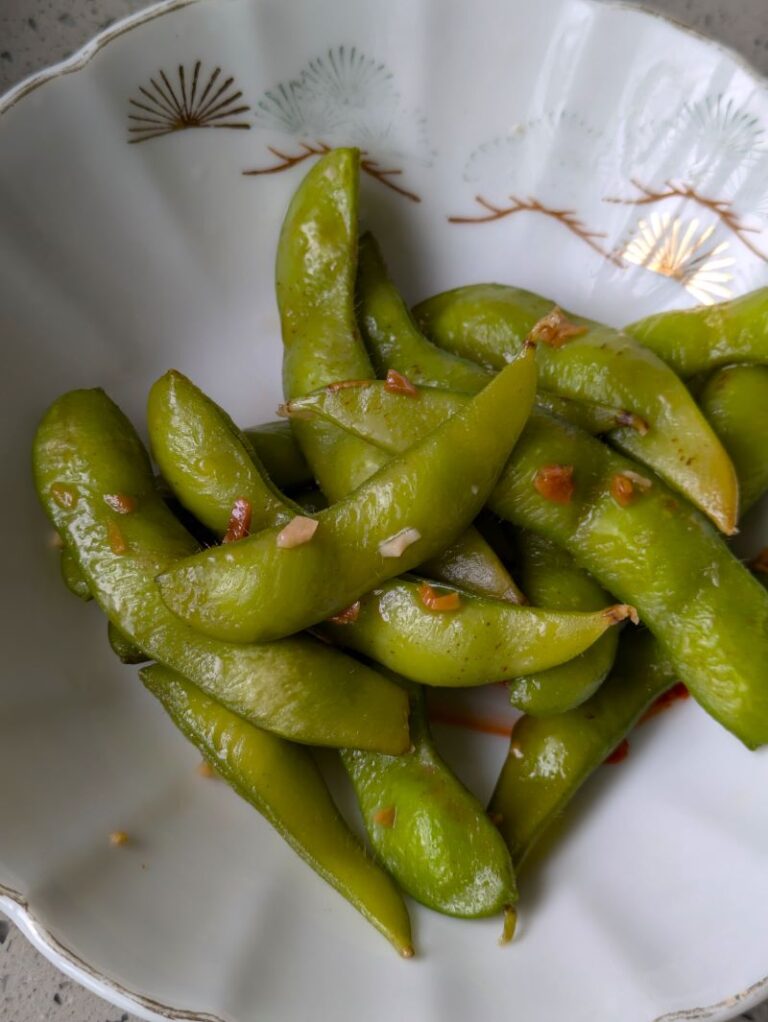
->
xmin=507 ymin=529 xmax=619 ymax=716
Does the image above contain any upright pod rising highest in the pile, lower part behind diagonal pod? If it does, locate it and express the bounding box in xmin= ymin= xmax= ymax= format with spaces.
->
xmin=276 ymin=149 xmax=513 ymax=596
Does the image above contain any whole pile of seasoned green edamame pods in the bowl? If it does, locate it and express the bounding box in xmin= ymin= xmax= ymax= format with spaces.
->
xmin=34 ymin=149 xmax=768 ymax=957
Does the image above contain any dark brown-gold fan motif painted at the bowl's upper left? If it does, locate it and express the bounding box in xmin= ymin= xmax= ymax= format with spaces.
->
xmin=128 ymin=60 xmax=251 ymax=143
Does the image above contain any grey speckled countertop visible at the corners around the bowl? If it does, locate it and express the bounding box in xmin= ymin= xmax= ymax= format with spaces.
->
xmin=0 ymin=0 xmax=768 ymax=1022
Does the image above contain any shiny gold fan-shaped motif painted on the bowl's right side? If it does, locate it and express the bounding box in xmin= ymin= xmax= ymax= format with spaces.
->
xmin=621 ymin=212 xmax=735 ymax=306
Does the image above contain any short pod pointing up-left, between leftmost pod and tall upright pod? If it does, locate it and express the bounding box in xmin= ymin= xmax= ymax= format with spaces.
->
xmin=147 ymin=370 xmax=292 ymax=537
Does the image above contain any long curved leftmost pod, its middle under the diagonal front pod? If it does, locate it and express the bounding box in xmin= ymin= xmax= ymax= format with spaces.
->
xmin=34 ymin=390 xmax=408 ymax=754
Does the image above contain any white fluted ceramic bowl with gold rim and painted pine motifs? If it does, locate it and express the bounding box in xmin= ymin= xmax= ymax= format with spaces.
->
xmin=0 ymin=0 xmax=768 ymax=1022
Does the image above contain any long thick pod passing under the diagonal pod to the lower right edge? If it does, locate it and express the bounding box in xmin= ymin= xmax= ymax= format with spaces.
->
xmin=290 ymin=383 xmax=768 ymax=748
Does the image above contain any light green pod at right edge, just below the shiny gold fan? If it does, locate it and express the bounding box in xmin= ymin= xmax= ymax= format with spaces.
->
xmin=624 ymin=287 xmax=768 ymax=377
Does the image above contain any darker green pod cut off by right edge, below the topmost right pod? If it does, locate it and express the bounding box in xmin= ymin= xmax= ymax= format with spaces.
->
xmin=697 ymin=366 xmax=768 ymax=514
